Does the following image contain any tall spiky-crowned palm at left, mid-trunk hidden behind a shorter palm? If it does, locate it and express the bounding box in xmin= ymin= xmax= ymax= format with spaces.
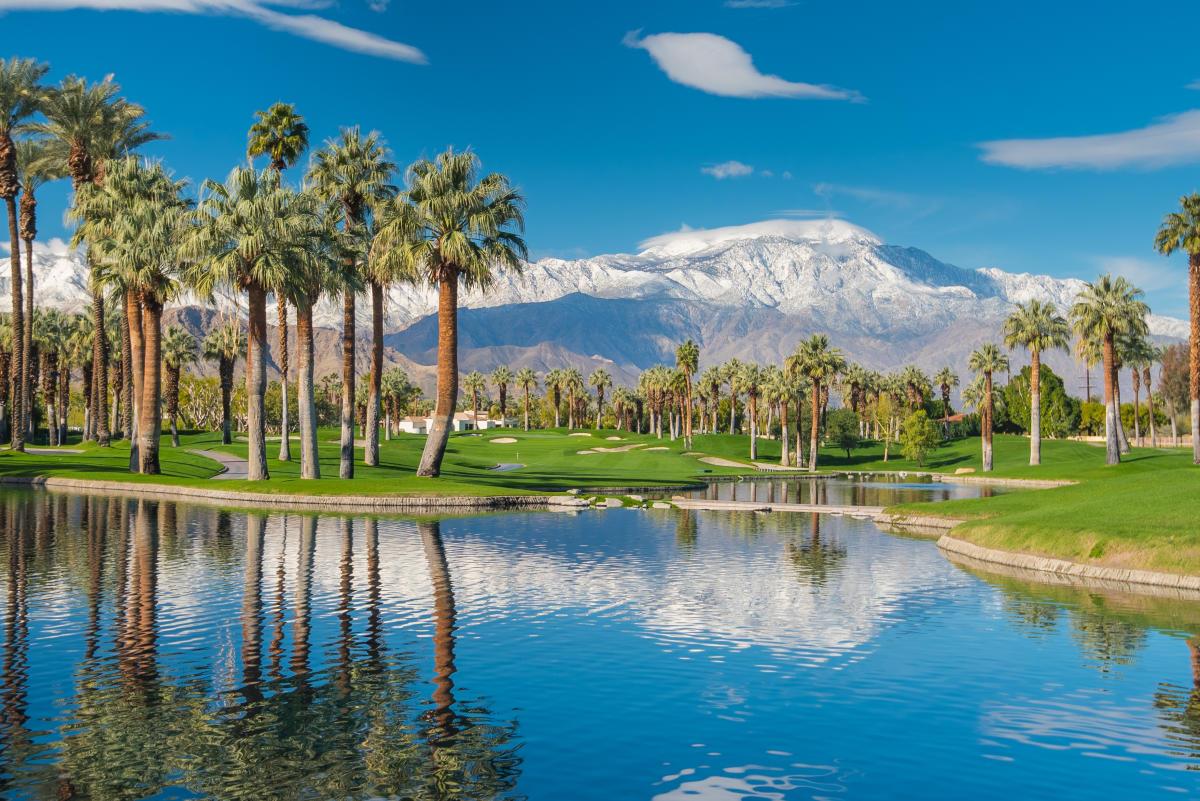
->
xmin=31 ymin=76 xmax=163 ymax=446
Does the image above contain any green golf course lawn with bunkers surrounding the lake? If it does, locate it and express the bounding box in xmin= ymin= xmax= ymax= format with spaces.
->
xmin=9 ymin=429 xmax=1200 ymax=574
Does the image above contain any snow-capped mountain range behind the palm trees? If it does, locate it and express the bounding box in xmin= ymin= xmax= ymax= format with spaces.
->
xmin=0 ymin=219 xmax=1187 ymax=388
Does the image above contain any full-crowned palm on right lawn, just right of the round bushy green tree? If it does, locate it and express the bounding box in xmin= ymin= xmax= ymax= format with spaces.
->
xmin=1070 ymin=273 xmax=1150 ymax=464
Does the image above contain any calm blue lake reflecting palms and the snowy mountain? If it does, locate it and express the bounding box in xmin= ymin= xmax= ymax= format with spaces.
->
xmin=0 ymin=480 xmax=1200 ymax=801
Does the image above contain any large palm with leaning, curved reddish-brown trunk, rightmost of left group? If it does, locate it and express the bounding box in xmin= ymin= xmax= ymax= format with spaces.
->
xmin=373 ymin=150 xmax=527 ymax=476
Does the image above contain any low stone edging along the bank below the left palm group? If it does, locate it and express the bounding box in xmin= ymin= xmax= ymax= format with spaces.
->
xmin=0 ymin=476 xmax=588 ymax=512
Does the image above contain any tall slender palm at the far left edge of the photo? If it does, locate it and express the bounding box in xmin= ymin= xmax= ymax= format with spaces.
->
xmin=0 ymin=58 xmax=49 ymax=451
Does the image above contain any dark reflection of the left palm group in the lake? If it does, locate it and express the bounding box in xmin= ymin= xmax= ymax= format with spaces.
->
xmin=0 ymin=494 xmax=521 ymax=800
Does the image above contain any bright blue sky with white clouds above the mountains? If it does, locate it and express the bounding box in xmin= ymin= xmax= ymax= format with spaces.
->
xmin=0 ymin=0 xmax=1200 ymax=317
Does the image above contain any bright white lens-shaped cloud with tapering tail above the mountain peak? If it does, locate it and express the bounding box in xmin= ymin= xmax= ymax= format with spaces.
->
xmin=625 ymin=31 xmax=862 ymax=101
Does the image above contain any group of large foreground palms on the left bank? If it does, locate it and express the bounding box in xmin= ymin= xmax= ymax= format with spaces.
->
xmin=0 ymin=59 xmax=526 ymax=480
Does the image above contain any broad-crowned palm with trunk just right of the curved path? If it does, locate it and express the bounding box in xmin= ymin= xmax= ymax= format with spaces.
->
xmin=181 ymin=168 xmax=316 ymax=481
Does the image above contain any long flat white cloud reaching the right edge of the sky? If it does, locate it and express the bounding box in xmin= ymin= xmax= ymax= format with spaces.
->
xmin=979 ymin=110 xmax=1200 ymax=169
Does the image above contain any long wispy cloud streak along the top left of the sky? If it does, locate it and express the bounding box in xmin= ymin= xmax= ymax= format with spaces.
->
xmin=0 ymin=0 xmax=427 ymax=64
